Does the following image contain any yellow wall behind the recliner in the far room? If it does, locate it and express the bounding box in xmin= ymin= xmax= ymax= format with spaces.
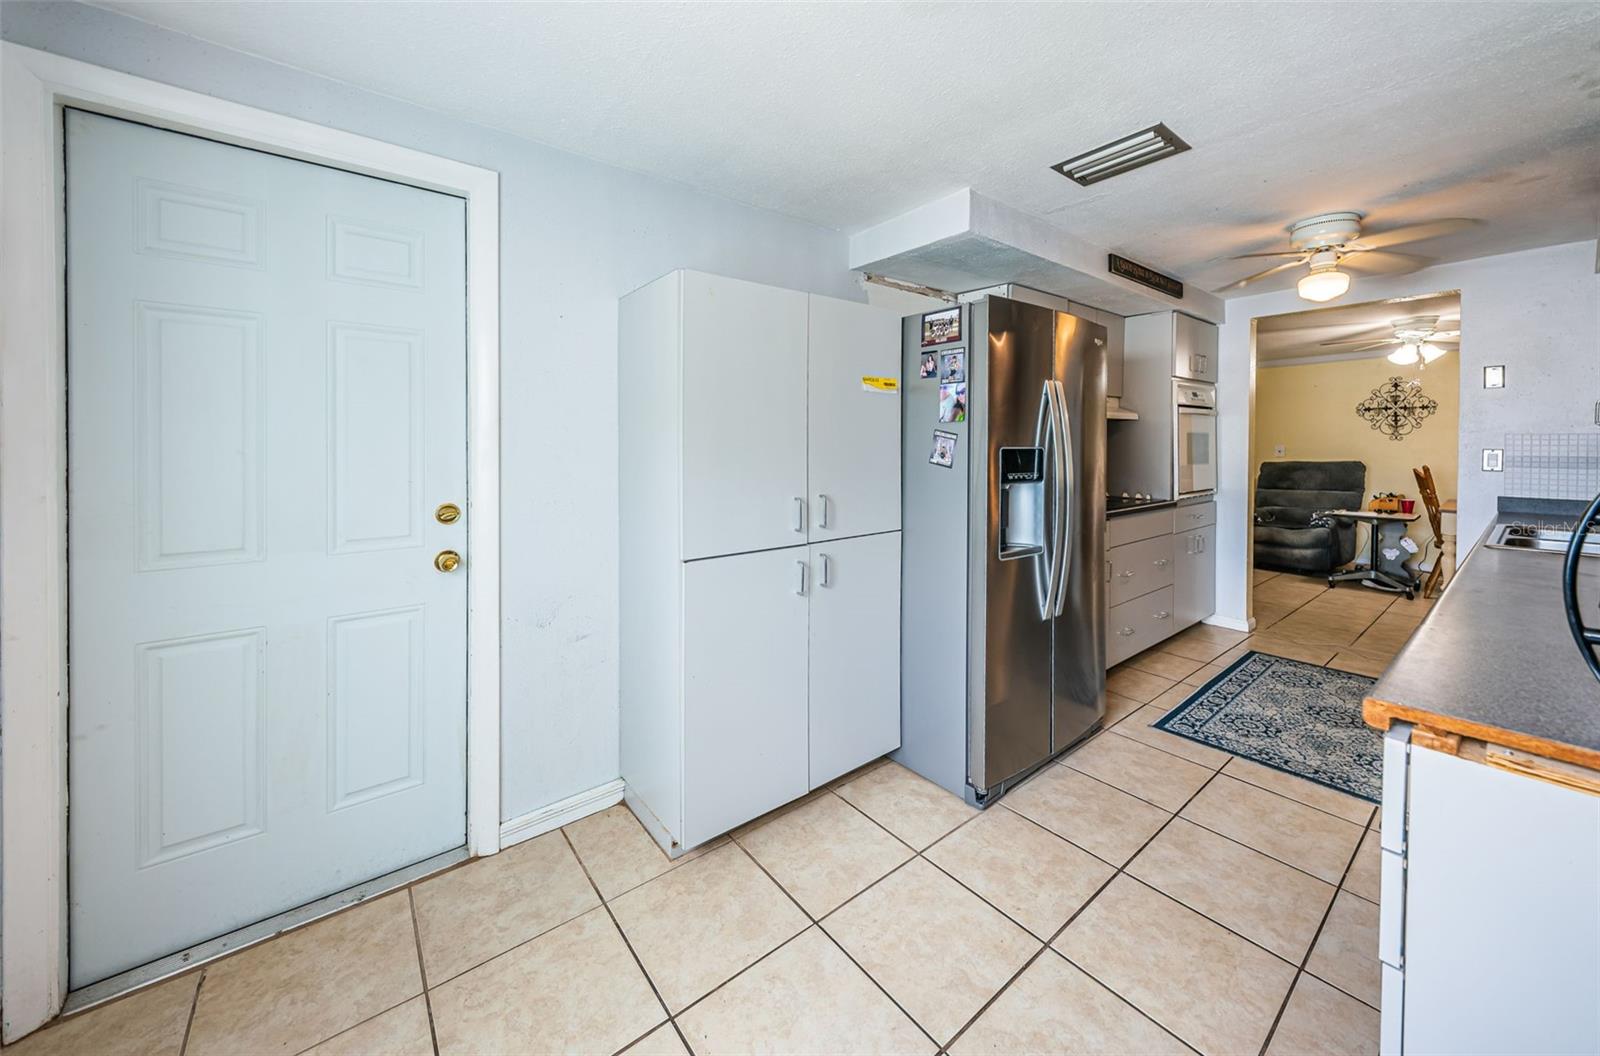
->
xmin=1251 ymin=352 xmax=1461 ymax=528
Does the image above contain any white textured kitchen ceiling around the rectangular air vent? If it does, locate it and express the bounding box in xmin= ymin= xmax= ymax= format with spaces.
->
xmin=102 ymin=0 xmax=1600 ymax=293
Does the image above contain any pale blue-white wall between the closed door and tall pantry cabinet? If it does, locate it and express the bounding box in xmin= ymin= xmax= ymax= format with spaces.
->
xmin=0 ymin=2 xmax=866 ymax=818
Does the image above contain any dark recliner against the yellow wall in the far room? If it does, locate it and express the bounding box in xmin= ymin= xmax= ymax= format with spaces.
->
xmin=1256 ymin=462 xmax=1366 ymax=573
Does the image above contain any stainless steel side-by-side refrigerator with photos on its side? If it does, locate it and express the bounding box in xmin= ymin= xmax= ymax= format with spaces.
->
xmin=894 ymin=296 xmax=1106 ymax=806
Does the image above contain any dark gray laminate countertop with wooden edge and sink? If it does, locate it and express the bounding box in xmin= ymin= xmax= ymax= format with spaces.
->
xmin=1365 ymin=499 xmax=1600 ymax=770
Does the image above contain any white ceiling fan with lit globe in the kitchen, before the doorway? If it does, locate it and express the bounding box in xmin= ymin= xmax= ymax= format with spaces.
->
xmin=1218 ymin=211 xmax=1477 ymax=301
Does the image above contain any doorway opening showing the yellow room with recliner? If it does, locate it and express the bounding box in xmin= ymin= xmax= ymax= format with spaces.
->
xmin=1250 ymin=291 xmax=1461 ymax=675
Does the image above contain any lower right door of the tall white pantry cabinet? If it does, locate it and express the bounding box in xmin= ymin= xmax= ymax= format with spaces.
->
xmin=808 ymin=531 xmax=901 ymax=789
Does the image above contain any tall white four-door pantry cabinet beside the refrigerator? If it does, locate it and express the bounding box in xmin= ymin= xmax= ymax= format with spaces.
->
xmin=618 ymin=272 xmax=901 ymax=856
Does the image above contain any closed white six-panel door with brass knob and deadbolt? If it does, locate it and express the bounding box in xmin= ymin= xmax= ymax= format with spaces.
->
xmin=67 ymin=110 xmax=470 ymax=987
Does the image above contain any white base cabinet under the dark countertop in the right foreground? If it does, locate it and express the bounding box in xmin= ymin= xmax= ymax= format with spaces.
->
xmin=1374 ymin=723 xmax=1600 ymax=1056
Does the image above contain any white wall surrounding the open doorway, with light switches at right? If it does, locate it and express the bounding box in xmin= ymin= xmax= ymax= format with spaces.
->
xmin=1216 ymin=242 xmax=1600 ymax=619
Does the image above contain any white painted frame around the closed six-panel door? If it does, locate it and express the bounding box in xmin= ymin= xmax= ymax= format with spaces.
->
xmin=0 ymin=43 xmax=501 ymax=1042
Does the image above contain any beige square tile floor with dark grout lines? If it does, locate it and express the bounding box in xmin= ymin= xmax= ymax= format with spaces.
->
xmin=8 ymin=573 xmax=1427 ymax=1056
